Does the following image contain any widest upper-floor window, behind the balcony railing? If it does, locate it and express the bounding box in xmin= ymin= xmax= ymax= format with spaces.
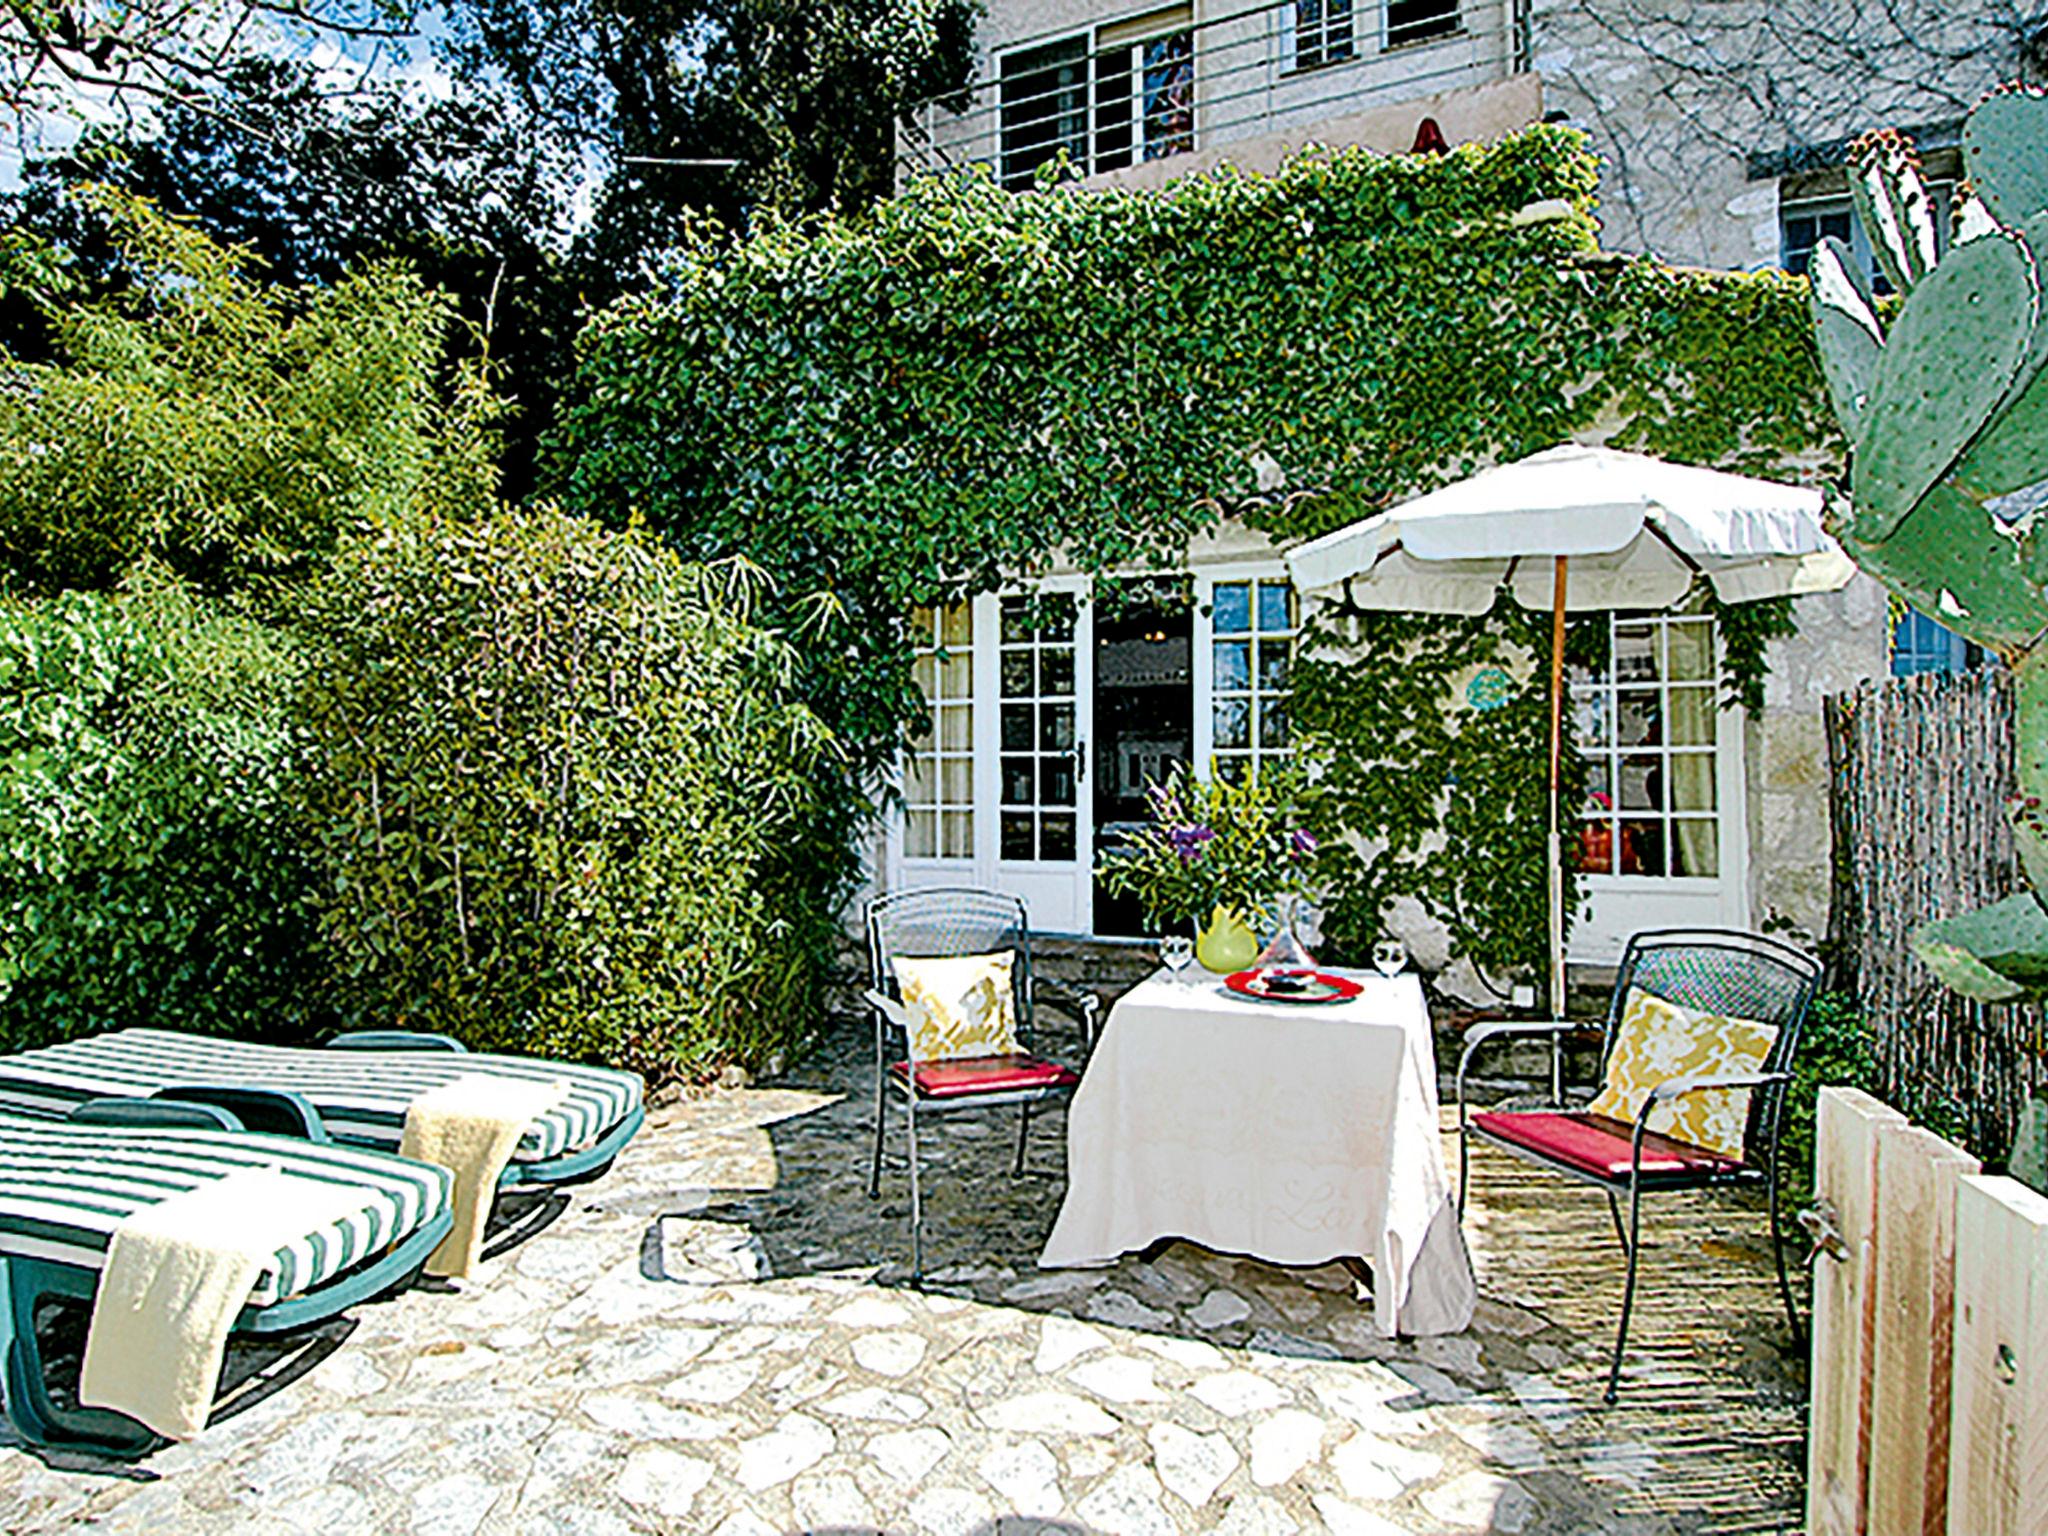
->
xmin=999 ymin=0 xmax=1196 ymax=190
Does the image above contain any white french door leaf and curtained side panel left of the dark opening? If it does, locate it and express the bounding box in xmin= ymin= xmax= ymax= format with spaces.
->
xmin=885 ymin=578 xmax=1094 ymax=934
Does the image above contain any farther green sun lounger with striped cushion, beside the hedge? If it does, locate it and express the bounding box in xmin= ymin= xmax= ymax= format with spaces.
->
xmin=0 ymin=1030 xmax=645 ymax=1188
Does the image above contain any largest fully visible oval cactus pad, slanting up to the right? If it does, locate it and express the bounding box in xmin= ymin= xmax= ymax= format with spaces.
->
xmin=1853 ymin=231 xmax=2036 ymax=539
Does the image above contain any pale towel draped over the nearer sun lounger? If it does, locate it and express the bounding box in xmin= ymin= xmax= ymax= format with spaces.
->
xmin=78 ymin=1167 xmax=373 ymax=1440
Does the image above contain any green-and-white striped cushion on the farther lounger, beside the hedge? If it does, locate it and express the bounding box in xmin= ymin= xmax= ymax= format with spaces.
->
xmin=0 ymin=1030 xmax=641 ymax=1161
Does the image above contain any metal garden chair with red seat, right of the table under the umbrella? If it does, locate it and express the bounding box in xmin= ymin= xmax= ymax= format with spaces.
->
xmin=1458 ymin=928 xmax=1821 ymax=1403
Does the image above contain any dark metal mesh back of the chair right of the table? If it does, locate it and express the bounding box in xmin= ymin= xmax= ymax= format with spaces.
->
xmin=1599 ymin=928 xmax=1821 ymax=1174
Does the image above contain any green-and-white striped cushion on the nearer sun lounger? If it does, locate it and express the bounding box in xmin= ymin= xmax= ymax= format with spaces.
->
xmin=0 ymin=1112 xmax=451 ymax=1307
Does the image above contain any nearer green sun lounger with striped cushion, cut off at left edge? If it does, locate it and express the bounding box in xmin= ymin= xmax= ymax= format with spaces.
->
xmin=0 ymin=1100 xmax=451 ymax=1456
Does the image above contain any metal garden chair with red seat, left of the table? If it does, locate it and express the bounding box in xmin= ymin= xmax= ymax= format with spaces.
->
xmin=866 ymin=887 xmax=1100 ymax=1280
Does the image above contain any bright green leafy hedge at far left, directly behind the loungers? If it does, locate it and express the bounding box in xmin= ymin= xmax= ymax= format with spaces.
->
xmin=0 ymin=592 xmax=315 ymax=1049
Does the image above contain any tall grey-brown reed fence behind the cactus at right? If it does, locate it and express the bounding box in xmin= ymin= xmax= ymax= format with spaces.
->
xmin=1825 ymin=668 xmax=2048 ymax=1157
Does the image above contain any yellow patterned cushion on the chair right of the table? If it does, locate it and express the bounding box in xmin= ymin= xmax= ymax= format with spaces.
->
xmin=1587 ymin=987 xmax=1778 ymax=1157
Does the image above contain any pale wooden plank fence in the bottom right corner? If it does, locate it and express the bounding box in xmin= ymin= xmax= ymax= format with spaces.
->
xmin=1806 ymin=1087 xmax=2048 ymax=1536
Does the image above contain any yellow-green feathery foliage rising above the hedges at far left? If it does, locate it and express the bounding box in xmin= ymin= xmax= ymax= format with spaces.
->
xmin=0 ymin=190 xmax=494 ymax=592
